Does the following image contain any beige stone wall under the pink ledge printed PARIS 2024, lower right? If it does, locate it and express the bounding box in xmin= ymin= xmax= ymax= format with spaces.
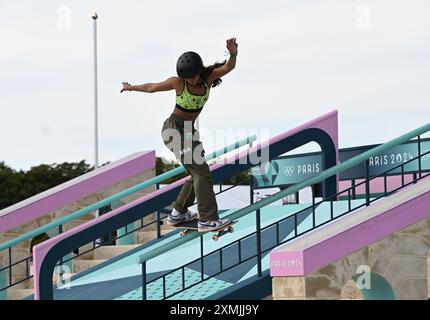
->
xmin=273 ymin=218 xmax=430 ymax=300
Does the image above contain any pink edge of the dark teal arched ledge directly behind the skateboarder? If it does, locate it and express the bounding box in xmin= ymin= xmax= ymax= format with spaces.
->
xmin=33 ymin=110 xmax=338 ymax=300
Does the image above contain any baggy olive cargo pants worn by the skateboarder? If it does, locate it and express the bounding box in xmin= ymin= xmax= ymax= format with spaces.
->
xmin=161 ymin=113 xmax=219 ymax=221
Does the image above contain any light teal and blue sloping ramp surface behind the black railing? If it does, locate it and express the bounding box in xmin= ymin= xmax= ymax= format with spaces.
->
xmin=40 ymin=199 xmax=364 ymax=300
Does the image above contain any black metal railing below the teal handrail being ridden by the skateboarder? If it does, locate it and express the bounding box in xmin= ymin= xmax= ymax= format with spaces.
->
xmin=141 ymin=149 xmax=430 ymax=300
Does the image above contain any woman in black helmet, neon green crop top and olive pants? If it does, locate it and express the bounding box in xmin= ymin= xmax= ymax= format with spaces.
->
xmin=121 ymin=38 xmax=238 ymax=232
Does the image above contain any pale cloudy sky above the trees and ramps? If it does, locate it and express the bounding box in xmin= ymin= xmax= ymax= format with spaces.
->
xmin=0 ymin=0 xmax=430 ymax=170
